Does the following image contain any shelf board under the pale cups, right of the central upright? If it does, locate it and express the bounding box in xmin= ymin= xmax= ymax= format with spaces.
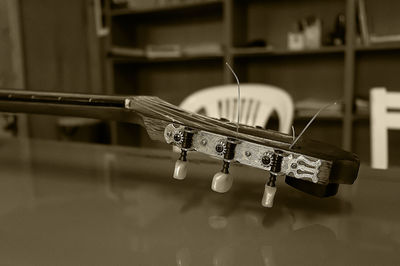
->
xmin=230 ymin=46 xmax=344 ymax=57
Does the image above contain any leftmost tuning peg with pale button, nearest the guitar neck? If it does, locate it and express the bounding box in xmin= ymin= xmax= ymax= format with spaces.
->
xmin=173 ymin=128 xmax=194 ymax=180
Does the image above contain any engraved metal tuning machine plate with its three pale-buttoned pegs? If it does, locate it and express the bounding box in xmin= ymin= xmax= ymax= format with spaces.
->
xmin=164 ymin=123 xmax=332 ymax=208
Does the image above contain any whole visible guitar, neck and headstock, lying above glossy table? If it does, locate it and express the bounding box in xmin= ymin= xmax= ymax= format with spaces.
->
xmin=0 ymin=90 xmax=360 ymax=207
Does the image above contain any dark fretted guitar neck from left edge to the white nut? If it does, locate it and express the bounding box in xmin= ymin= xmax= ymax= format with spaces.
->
xmin=0 ymin=90 xmax=142 ymax=124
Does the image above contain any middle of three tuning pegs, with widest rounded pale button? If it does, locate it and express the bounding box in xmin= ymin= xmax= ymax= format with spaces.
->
xmin=211 ymin=138 xmax=237 ymax=193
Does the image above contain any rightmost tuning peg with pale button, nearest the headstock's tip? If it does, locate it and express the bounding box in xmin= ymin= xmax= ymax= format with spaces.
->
xmin=261 ymin=151 xmax=283 ymax=208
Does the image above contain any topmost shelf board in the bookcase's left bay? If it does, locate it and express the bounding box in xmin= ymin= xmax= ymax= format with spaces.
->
xmin=110 ymin=0 xmax=222 ymax=16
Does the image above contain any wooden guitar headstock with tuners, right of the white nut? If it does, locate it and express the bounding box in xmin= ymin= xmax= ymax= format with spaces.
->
xmin=128 ymin=97 xmax=359 ymax=207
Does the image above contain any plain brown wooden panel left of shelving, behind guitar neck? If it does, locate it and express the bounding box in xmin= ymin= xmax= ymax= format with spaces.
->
xmin=21 ymin=0 xmax=101 ymax=139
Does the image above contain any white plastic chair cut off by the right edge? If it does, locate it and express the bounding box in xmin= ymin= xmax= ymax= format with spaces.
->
xmin=370 ymin=88 xmax=400 ymax=169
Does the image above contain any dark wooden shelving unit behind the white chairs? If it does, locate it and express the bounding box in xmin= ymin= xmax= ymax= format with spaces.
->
xmin=105 ymin=0 xmax=400 ymax=164
